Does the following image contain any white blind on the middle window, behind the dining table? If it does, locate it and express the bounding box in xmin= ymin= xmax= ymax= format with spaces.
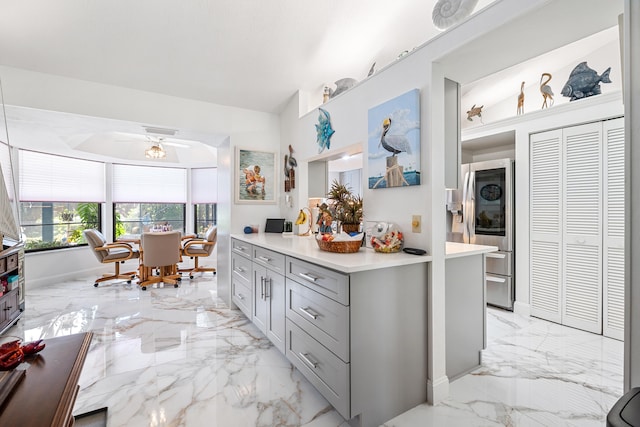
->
xmin=112 ymin=165 xmax=187 ymax=203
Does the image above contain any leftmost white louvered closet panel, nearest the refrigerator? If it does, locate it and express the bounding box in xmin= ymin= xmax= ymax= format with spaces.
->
xmin=529 ymin=130 xmax=562 ymax=322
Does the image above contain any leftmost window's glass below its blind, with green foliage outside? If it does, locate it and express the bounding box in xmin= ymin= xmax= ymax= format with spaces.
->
xmin=20 ymin=202 xmax=101 ymax=251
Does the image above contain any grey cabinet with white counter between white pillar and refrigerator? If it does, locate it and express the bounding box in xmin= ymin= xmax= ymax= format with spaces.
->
xmin=445 ymin=242 xmax=498 ymax=381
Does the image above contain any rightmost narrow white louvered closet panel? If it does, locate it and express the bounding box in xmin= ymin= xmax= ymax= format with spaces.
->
xmin=602 ymin=119 xmax=625 ymax=340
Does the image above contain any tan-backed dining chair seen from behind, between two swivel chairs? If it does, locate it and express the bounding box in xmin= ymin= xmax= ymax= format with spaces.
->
xmin=138 ymin=231 xmax=182 ymax=291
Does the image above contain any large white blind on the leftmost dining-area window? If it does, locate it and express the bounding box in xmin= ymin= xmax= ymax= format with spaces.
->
xmin=19 ymin=150 xmax=105 ymax=203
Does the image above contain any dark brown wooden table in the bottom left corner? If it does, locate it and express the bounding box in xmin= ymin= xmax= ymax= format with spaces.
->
xmin=0 ymin=332 xmax=93 ymax=427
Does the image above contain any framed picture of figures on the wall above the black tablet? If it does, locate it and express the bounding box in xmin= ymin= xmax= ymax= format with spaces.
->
xmin=234 ymin=148 xmax=278 ymax=204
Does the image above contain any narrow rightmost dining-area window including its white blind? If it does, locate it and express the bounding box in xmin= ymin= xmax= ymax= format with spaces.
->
xmin=191 ymin=168 xmax=218 ymax=237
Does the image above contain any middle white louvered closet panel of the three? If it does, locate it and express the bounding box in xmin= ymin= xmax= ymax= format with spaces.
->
xmin=562 ymin=123 xmax=602 ymax=334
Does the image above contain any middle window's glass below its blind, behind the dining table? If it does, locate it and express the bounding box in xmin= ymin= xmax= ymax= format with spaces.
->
xmin=113 ymin=203 xmax=185 ymax=239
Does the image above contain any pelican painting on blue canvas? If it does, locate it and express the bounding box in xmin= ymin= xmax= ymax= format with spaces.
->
xmin=367 ymin=89 xmax=420 ymax=189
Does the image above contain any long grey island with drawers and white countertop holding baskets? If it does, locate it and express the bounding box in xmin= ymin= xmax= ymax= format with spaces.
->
xmin=231 ymin=233 xmax=432 ymax=426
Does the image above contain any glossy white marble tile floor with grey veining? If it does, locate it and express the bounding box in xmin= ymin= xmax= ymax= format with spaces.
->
xmin=7 ymin=273 xmax=623 ymax=427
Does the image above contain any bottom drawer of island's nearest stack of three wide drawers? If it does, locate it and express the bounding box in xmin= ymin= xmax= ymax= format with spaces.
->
xmin=286 ymin=319 xmax=350 ymax=420
